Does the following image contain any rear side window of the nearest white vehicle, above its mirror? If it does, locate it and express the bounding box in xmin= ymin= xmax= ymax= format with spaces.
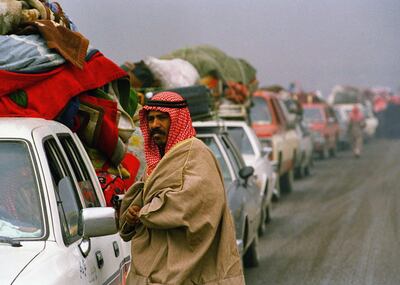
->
xmin=58 ymin=134 xmax=101 ymax=207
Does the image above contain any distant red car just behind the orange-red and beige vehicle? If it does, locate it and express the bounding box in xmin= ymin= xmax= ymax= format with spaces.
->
xmin=302 ymin=102 xmax=339 ymax=159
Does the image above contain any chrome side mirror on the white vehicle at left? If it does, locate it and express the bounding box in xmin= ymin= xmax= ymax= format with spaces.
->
xmin=81 ymin=207 xmax=118 ymax=238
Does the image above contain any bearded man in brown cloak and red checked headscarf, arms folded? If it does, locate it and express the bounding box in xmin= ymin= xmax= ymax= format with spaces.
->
xmin=120 ymin=92 xmax=244 ymax=285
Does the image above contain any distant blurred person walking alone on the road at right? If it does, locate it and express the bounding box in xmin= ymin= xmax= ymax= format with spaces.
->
xmin=348 ymin=105 xmax=365 ymax=158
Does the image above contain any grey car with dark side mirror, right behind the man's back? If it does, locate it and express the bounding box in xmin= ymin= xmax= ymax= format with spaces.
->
xmin=196 ymin=131 xmax=263 ymax=267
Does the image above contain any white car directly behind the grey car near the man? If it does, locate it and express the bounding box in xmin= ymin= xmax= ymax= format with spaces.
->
xmin=193 ymin=118 xmax=279 ymax=234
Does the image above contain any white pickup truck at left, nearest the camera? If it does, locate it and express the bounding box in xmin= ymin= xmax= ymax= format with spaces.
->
xmin=0 ymin=118 xmax=130 ymax=285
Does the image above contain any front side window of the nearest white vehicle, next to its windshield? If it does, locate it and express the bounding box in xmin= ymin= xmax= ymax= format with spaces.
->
xmin=43 ymin=138 xmax=82 ymax=244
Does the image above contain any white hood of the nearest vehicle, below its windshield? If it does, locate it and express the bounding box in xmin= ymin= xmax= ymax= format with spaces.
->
xmin=0 ymin=241 xmax=45 ymax=284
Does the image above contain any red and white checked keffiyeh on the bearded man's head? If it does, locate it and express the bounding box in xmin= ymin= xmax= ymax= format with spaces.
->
xmin=139 ymin=92 xmax=196 ymax=175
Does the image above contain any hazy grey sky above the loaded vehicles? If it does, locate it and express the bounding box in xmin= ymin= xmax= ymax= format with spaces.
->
xmin=58 ymin=0 xmax=400 ymax=95
